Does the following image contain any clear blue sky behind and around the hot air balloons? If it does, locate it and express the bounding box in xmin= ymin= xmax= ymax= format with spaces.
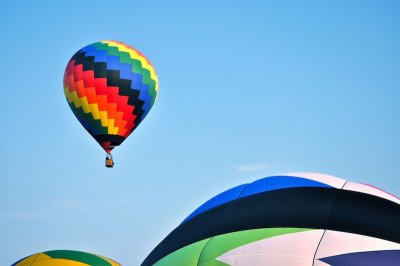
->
xmin=0 ymin=1 xmax=400 ymax=266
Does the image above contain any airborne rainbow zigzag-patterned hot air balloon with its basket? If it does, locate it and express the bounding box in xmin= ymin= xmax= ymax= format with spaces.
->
xmin=64 ymin=41 xmax=158 ymax=167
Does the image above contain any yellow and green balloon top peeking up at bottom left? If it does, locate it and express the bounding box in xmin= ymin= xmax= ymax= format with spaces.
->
xmin=11 ymin=250 xmax=121 ymax=266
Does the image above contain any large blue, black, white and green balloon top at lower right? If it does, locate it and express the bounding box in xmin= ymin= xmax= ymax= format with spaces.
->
xmin=142 ymin=173 xmax=400 ymax=266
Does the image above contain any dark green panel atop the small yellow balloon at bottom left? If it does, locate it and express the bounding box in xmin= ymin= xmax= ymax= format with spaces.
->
xmin=43 ymin=250 xmax=112 ymax=266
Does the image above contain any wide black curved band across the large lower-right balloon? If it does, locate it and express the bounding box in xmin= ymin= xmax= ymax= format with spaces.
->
xmin=142 ymin=187 xmax=400 ymax=266
